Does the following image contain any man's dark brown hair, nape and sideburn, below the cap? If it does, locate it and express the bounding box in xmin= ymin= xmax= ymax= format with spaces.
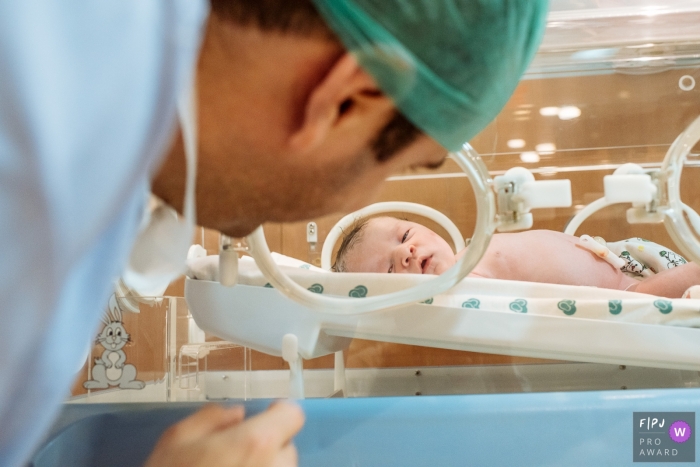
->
xmin=211 ymin=0 xmax=421 ymax=162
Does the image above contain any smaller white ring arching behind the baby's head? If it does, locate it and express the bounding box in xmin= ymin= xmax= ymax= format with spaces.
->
xmin=321 ymin=201 xmax=466 ymax=271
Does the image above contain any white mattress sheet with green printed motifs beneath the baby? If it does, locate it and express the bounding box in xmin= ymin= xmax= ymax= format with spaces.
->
xmin=228 ymin=254 xmax=700 ymax=327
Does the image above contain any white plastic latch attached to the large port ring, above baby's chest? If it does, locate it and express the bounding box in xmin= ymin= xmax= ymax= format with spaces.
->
xmin=494 ymin=167 xmax=571 ymax=232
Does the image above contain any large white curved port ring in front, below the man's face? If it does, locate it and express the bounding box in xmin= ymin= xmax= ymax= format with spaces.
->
xmin=248 ymin=144 xmax=496 ymax=314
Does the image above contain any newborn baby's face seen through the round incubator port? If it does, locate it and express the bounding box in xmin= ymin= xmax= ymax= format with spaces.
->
xmin=345 ymin=217 xmax=455 ymax=274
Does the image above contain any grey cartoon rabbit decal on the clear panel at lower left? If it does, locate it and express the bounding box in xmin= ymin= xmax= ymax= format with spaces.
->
xmin=83 ymin=295 xmax=146 ymax=389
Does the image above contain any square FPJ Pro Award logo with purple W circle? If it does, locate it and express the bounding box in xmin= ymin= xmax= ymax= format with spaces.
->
xmin=633 ymin=412 xmax=695 ymax=462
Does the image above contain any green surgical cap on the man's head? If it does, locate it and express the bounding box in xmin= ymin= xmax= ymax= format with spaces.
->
xmin=314 ymin=0 xmax=547 ymax=151
